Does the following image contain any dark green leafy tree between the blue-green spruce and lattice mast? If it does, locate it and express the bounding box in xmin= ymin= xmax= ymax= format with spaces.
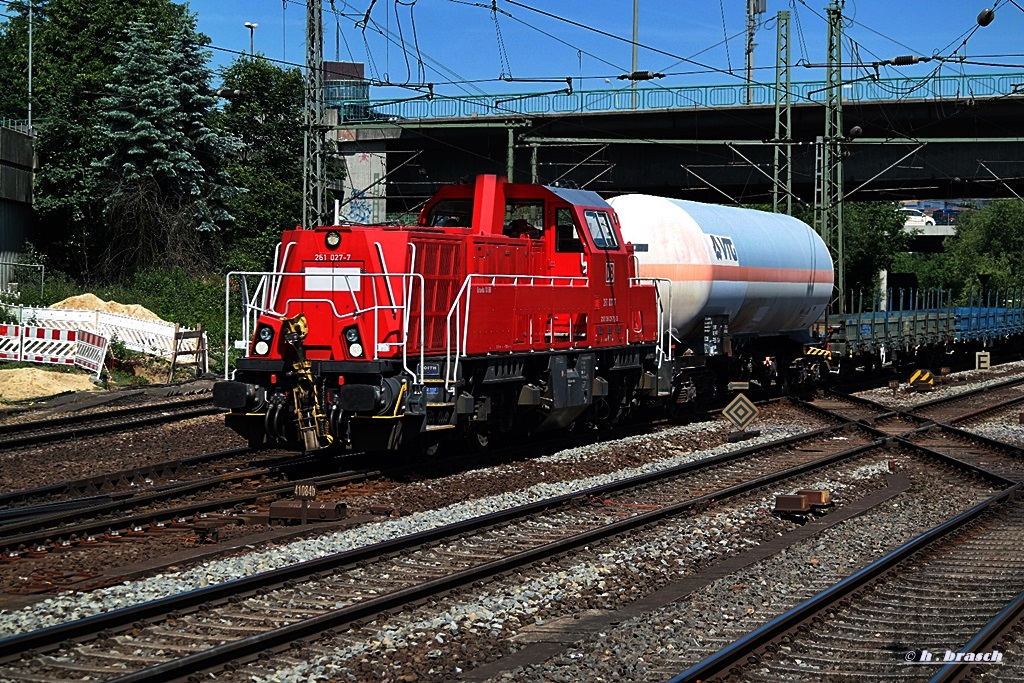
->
xmin=209 ymin=55 xmax=303 ymax=270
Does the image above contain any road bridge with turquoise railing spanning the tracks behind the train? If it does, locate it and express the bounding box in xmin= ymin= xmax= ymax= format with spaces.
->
xmin=329 ymin=73 xmax=1024 ymax=219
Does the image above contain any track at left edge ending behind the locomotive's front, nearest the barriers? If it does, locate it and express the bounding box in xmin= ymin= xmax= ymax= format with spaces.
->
xmin=0 ymin=396 xmax=223 ymax=451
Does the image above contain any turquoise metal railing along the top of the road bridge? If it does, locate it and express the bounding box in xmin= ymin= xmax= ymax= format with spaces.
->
xmin=328 ymin=72 xmax=1024 ymax=123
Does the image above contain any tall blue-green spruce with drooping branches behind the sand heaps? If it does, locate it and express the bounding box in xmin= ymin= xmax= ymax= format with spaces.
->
xmin=93 ymin=14 xmax=234 ymax=278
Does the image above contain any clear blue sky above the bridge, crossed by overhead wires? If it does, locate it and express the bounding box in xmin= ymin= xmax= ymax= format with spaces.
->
xmin=188 ymin=0 xmax=1024 ymax=94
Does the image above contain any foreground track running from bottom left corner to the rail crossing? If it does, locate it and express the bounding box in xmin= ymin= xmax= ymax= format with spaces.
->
xmin=0 ymin=427 xmax=905 ymax=681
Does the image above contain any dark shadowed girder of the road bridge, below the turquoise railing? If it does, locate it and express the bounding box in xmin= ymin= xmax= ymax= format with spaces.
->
xmin=343 ymin=96 xmax=1024 ymax=210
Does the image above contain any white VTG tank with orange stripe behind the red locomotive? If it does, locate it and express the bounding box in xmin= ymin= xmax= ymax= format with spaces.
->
xmin=608 ymin=195 xmax=834 ymax=339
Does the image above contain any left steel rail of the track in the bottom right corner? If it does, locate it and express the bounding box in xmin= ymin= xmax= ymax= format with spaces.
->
xmin=668 ymin=483 xmax=1021 ymax=683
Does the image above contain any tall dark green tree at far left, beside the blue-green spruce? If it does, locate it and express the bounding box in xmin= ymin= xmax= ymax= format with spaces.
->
xmin=9 ymin=0 xmax=192 ymax=282
